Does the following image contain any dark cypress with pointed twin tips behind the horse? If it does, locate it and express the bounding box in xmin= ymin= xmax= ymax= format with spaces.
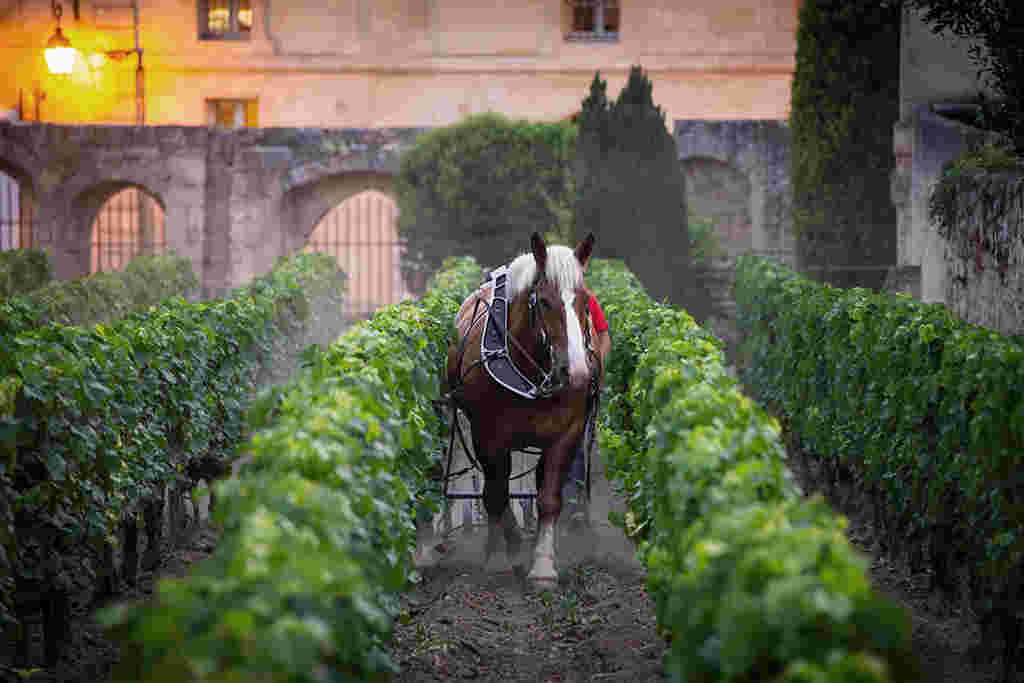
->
xmin=575 ymin=67 xmax=693 ymax=306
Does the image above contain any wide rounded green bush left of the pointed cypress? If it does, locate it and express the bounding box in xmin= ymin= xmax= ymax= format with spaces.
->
xmin=395 ymin=113 xmax=577 ymax=282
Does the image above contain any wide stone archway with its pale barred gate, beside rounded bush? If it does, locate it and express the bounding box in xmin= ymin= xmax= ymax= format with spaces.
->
xmin=284 ymin=171 xmax=412 ymax=319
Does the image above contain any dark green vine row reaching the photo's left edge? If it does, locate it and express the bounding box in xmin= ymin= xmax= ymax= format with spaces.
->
xmin=0 ymin=254 xmax=343 ymax=634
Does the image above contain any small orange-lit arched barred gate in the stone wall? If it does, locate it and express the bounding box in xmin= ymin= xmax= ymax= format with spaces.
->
xmin=89 ymin=187 xmax=167 ymax=272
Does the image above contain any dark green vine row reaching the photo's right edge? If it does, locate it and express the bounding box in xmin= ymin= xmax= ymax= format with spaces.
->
xmin=736 ymin=252 xmax=1024 ymax=671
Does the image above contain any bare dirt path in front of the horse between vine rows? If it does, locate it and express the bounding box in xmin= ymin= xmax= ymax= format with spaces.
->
xmin=394 ymin=440 xmax=665 ymax=683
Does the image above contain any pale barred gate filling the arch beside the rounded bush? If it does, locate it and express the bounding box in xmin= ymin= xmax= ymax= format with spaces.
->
xmin=305 ymin=189 xmax=412 ymax=323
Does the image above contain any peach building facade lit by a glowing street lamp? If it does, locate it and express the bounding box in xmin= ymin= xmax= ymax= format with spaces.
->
xmin=0 ymin=0 xmax=799 ymax=128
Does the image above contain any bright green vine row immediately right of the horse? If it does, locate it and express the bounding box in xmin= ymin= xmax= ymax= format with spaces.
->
xmin=588 ymin=261 xmax=913 ymax=682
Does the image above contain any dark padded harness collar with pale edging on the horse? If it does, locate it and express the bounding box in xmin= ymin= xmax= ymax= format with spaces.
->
xmin=480 ymin=265 xmax=561 ymax=399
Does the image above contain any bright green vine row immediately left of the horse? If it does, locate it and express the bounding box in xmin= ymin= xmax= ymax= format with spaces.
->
xmin=100 ymin=258 xmax=481 ymax=681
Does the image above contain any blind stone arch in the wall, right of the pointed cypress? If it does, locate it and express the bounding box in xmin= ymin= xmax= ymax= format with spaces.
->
xmin=680 ymin=157 xmax=754 ymax=260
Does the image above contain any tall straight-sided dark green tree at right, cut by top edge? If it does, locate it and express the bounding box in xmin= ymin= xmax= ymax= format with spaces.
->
xmin=790 ymin=0 xmax=900 ymax=289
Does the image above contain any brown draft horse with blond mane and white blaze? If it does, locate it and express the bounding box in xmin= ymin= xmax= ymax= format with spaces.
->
xmin=445 ymin=232 xmax=596 ymax=586
